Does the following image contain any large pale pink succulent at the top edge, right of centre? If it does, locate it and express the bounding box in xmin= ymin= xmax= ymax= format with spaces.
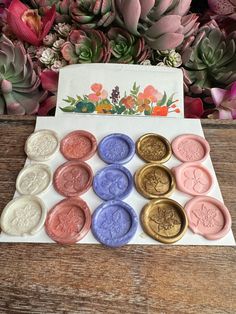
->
xmin=115 ymin=0 xmax=199 ymax=50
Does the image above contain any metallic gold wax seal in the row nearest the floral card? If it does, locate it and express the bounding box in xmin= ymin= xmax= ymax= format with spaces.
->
xmin=136 ymin=133 xmax=171 ymax=164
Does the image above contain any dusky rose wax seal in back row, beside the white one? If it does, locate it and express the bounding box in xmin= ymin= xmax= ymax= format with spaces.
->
xmin=60 ymin=131 xmax=97 ymax=161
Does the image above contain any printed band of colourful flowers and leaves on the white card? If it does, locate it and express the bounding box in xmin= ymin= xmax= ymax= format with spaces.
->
xmin=60 ymin=82 xmax=181 ymax=116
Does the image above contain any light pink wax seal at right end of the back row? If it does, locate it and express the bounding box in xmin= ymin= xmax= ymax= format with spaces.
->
xmin=171 ymin=134 xmax=210 ymax=162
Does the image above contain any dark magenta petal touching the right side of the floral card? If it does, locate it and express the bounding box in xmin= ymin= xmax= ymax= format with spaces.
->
xmin=184 ymin=96 xmax=204 ymax=119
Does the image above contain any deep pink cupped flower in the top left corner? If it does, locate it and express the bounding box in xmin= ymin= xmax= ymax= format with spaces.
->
xmin=7 ymin=0 xmax=56 ymax=46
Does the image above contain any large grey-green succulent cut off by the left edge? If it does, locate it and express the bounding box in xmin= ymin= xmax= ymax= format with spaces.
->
xmin=0 ymin=35 xmax=44 ymax=114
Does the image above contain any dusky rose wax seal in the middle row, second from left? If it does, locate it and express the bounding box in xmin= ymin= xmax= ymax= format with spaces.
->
xmin=53 ymin=161 xmax=93 ymax=196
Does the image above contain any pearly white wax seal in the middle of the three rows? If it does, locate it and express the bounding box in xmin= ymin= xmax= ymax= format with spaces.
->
xmin=16 ymin=164 xmax=52 ymax=195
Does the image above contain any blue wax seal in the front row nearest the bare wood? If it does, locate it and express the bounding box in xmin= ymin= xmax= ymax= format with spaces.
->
xmin=92 ymin=200 xmax=138 ymax=247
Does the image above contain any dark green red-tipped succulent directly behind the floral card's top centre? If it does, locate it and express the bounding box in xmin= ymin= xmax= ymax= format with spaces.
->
xmin=107 ymin=27 xmax=150 ymax=63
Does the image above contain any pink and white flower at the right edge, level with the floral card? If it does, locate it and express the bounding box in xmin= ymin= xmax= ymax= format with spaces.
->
xmin=211 ymin=82 xmax=236 ymax=119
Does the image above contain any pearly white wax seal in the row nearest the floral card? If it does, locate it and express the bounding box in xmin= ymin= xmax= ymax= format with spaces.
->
xmin=25 ymin=130 xmax=59 ymax=161
